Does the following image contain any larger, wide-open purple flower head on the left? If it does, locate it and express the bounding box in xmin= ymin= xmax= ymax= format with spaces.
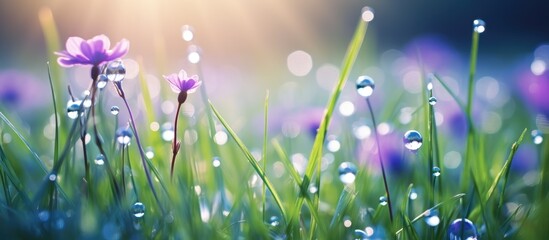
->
xmin=55 ymin=35 xmax=130 ymax=67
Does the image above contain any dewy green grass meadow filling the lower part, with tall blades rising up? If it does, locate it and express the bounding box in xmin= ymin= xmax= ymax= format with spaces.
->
xmin=0 ymin=6 xmax=549 ymax=239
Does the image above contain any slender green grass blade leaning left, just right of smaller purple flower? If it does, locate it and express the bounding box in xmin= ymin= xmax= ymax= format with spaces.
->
xmin=208 ymin=101 xmax=288 ymax=222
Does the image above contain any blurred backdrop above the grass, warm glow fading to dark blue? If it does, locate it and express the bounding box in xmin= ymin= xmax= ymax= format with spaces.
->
xmin=0 ymin=0 xmax=549 ymax=135
